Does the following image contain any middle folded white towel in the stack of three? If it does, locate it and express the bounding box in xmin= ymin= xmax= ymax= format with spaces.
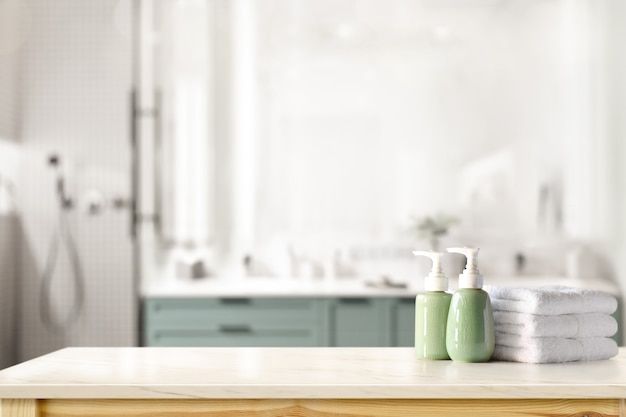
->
xmin=493 ymin=311 xmax=617 ymax=337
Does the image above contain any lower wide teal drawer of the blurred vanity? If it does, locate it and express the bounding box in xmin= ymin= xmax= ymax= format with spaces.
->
xmin=147 ymin=325 xmax=318 ymax=347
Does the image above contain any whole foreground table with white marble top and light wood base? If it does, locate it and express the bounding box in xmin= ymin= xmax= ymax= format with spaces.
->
xmin=0 ymin=348 xmax=626 ymax=417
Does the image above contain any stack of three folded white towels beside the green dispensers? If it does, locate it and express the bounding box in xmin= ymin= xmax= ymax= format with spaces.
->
xmin=486 ymin=287 xmax=617 ymax=363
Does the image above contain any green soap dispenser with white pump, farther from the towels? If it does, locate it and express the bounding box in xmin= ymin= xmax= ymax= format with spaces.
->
xmin=413 ymin=251 xmax=452 ymax=360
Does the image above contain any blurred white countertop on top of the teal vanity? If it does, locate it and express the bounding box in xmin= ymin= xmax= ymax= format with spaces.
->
xmin=141 ymin=277 xmax=620 ymax=298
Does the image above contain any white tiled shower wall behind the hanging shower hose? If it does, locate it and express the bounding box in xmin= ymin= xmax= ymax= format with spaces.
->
xmin=18 ymin=0 xmax=136 ymax=360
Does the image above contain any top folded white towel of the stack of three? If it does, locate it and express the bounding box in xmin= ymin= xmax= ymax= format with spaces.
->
xmin=485 ymin=286 xmax=617 ymax=315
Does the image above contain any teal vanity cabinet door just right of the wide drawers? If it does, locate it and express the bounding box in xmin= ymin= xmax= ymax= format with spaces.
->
xmin=330 ymin=298 xmax=390 ymax=347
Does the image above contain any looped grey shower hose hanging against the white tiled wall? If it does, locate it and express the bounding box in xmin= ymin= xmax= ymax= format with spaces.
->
xmin=39 ymin=159 xmax=85 ymax=331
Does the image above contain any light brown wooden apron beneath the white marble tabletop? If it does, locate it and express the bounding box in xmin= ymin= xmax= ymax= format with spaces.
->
xmin=39 ymin=399 xmax=621 ymax=417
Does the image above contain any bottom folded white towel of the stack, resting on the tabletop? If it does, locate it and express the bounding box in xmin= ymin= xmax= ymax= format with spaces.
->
xmin=492 ymin=332 xmax=618 ymax=363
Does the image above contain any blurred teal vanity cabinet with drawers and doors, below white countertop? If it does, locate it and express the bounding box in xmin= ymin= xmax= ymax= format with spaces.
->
xmin=143 ymin=297 xmax=415 ymax=347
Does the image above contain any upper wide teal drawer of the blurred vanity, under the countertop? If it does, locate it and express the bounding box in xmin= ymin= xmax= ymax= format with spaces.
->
xmin=145 ymin=298 xmax=318 ymax=329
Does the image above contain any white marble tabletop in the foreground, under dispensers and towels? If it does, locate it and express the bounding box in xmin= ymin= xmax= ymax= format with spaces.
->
xmin=0 ymin=348 xmax=626 ymax=399
